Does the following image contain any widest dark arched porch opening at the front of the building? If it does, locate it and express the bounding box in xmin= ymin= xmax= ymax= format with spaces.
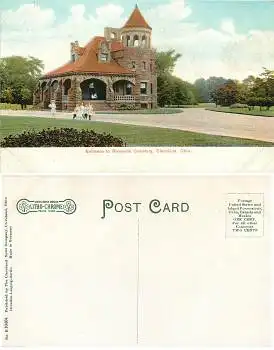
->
xmin=80 ymin=79 xmax=106 ymax=101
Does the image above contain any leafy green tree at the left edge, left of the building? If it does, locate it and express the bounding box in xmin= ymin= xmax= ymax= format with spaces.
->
xmin=0 ymin=56 xmax=44 ymax=104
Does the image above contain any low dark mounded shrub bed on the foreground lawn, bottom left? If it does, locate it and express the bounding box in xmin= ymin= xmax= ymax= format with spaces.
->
xmin=0 ymin=128 xmax=126 ymax=147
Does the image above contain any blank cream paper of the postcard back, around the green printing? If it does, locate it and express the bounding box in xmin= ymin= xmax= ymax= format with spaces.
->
xmin=2 ymin=176 xmax=272 ymax=346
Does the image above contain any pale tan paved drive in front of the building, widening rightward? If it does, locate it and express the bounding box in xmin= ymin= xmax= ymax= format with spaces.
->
xmin=0 ymin=108 xmax=274 ymax=142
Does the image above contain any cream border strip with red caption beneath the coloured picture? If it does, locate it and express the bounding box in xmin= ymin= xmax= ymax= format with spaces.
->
xmin=1 ymin=147 xmax=274 ymax=174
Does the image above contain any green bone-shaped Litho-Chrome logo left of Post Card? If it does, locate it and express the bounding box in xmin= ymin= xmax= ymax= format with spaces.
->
xmin=16 ymin=198 xmax=76 ymax=215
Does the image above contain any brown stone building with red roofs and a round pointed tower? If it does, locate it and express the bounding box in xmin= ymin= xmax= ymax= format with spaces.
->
xmin=34 ymin=5 xmax=157 ymax=111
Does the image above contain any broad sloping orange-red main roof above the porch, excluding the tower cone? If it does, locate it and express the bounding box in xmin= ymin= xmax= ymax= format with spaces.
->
xmin=45 ymin=36 xmax=134 ymax=77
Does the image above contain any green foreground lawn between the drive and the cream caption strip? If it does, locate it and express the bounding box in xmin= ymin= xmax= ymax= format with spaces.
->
xmin=0 ymin=116 xmax=274 ymax=146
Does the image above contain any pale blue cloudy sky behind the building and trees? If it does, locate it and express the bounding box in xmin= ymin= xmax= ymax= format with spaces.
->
xmin=0 ymin=0 xmax=274 ymax=82
